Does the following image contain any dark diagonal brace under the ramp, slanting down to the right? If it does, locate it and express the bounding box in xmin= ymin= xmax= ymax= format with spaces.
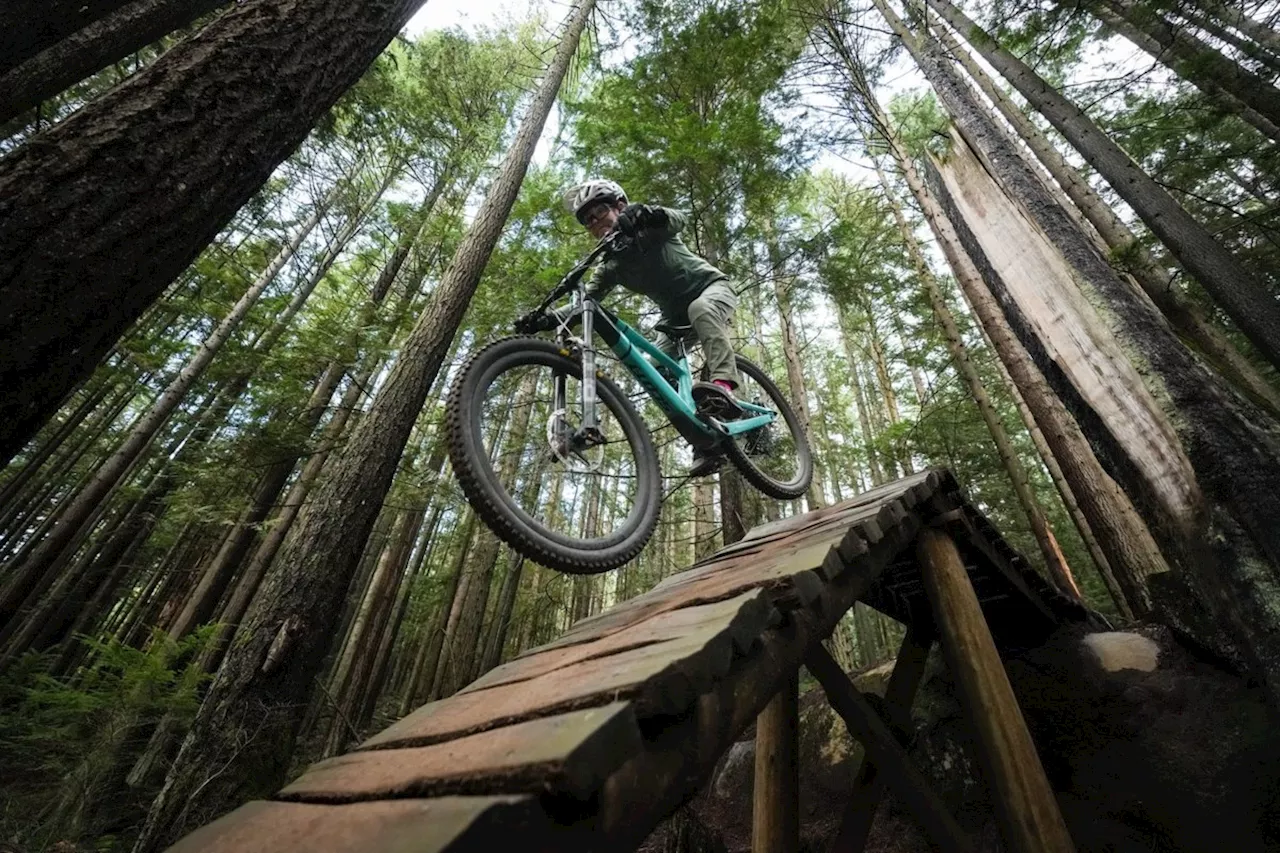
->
xmin=805 ymin=643 xmax=974 ymax=853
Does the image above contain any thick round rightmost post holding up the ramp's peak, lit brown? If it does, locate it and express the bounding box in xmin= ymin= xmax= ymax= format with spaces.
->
xmin=916 ymin=528 xmax=1075 ymax=853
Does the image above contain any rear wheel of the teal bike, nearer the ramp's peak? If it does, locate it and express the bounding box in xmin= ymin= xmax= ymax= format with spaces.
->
xmin=724 ymin=356 xmax=813 ymax=501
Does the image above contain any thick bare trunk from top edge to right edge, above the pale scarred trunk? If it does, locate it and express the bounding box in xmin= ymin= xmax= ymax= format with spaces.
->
xmin=928 ymin=0 xmax=1280 ymax=368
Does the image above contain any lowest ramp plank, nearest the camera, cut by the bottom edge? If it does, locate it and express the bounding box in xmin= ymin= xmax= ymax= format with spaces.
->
xmin=168 ymin=795 xmax=552 ymax=853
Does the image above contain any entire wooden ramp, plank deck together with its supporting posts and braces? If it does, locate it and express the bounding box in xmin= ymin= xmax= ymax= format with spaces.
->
xmin=170 ymin=470 xmax=1087 ymax=853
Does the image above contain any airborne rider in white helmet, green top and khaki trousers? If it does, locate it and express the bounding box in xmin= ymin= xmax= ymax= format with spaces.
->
xmin=564 ymin=179 xmax=742 ymax=476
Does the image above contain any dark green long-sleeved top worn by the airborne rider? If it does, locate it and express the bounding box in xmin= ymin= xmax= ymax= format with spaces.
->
xmin=586 ymin=207 xmax=728 ymax=325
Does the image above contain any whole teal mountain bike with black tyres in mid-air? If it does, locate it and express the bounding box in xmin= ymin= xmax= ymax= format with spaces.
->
xmin=445 ymin=232 xmax=813 ymax=574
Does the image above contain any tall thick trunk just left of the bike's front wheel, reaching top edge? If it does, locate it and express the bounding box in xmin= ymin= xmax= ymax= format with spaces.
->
xmin=134 ymin=0 xmax=594 ymax=853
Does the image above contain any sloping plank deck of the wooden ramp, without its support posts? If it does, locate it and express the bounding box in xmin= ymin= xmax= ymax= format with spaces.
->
xmin=170 ymin=470 xmax=1085 ymax=853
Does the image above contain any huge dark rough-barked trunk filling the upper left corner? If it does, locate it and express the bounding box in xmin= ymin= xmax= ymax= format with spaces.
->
xmin=0 ymin=0 xmax=421 ymax=464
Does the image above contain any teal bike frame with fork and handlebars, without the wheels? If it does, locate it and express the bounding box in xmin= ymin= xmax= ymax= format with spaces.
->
xmin=531 ymin=233 xmax=778 ymax=447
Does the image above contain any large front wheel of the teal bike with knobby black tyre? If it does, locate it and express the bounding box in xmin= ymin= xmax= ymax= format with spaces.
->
xmin=445 ymin=338 xmax=662 ymax=574
